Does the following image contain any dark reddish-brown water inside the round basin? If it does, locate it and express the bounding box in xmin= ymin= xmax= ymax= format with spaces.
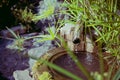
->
xmin=53 ymin=52 xmax=100 ymax=80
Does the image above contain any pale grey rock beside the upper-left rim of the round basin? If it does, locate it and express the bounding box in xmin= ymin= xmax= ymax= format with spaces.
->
xmin=28 ymin=41 xmax=54 ymax=69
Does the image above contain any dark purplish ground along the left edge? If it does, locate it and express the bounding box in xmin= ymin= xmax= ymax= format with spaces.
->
xmin=0 ymin=39 xmax=29 ymax=80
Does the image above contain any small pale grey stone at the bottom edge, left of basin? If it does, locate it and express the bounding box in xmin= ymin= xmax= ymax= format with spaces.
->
xmin=13 ymin=69 xmax=34 ymax=80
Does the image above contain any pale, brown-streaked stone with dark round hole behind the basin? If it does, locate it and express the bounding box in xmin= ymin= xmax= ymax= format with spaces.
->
xmin=60 ymin=23 xmax=94 ymax=53
